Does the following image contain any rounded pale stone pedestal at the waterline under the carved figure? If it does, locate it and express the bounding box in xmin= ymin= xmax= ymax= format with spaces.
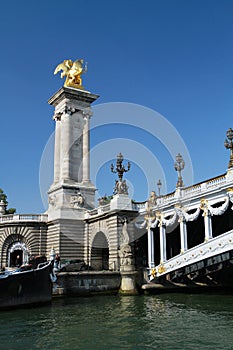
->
xmin=119 ymin=265 xmax=138 ymax=295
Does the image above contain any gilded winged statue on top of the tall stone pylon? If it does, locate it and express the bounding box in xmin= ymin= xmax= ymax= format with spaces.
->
xmin=54 ymin=59 xmax=87 ymax=89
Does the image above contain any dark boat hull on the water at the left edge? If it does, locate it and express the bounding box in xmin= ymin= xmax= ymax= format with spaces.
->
xmin=0 ymin=263 xmax=52 ymax=309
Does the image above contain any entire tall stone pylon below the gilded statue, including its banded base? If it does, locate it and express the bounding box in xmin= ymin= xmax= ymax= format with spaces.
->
xmin=47 ymin=87 xmax=99 ymax=259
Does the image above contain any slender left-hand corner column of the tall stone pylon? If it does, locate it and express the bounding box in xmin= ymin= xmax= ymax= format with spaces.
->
xmin=53 ymin=114 xmax=61 ymax=183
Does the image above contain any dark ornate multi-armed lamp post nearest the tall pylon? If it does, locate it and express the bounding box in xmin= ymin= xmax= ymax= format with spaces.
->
xmin=111 ymin=153 xmax=131 ymax=194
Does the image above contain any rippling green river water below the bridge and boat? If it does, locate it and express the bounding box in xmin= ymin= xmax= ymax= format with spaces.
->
xmin=0 ymin=294 xmax=233 ymax=350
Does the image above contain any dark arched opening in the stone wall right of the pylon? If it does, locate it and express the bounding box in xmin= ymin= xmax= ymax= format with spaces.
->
xmin=91 ymin=232 xmax=109 ymax=270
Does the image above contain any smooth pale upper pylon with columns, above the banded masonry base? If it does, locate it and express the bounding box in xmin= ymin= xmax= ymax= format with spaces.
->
xmin=48 ymin=87 xmax=99 ymax=221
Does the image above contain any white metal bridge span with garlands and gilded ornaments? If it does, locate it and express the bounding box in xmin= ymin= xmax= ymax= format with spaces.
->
xmin=134 ymin=171 xmax=233 ymax=288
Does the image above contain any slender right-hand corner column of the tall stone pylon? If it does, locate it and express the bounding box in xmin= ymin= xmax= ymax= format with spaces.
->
xmin=82 ymin=108 xmax=92 ymax=182
